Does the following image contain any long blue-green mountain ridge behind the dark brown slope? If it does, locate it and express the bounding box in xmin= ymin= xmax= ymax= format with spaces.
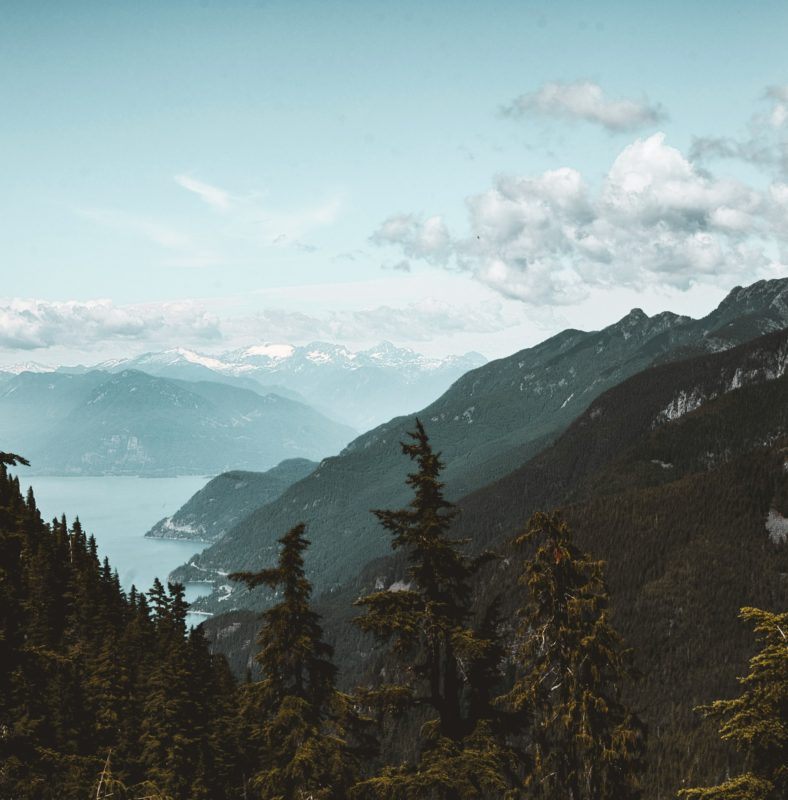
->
xmin=174 ymin=280 xmax=788 ymax=609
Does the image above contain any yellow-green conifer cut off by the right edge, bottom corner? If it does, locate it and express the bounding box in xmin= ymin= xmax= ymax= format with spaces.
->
xmin=679 ymin=607 xmax=788 ymax=800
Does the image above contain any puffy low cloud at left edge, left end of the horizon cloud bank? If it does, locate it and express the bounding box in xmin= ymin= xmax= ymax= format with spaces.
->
xmin=0 ymin=299 xmax=221 ymax=350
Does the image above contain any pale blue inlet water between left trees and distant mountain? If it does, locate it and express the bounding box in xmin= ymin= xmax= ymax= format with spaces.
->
xmin=15 ymin=476 xmax=214 ymax=625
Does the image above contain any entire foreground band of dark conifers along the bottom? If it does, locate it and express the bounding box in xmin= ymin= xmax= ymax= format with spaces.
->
xmin=0 ymin=422 xmax=788 ymax=800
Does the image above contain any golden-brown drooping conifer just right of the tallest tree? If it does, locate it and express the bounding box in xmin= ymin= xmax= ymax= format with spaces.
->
xmin=501 ymin=513 xmax=644 ymax=800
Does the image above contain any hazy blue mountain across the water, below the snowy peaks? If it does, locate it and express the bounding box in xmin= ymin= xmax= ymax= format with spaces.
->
xmin=20 ymin=370 xmax=353 ymax=475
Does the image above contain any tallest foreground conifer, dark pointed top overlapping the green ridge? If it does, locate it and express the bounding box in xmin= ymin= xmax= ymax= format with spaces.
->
xmin=355 ymin=419 xmax=512 ymax=800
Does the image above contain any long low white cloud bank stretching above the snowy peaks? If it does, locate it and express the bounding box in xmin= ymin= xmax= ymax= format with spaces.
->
xmin=0 ymin=298 xmax=522 ymax=355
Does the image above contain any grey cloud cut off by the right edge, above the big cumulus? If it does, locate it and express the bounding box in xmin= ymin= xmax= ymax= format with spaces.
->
xmin=690 ymin=84 xmax=788 ymax=178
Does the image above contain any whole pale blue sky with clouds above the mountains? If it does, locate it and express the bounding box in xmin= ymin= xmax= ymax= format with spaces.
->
xmin=0 ymin=0 xmax=788 ymax=365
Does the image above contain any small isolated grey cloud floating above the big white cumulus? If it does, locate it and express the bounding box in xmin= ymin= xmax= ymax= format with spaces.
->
xmin=502 ymin=81 xmax=666 ymax=133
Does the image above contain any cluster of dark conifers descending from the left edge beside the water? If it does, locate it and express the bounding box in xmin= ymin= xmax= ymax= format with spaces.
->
xmin=0 ymin=465 xmax=235 ymax=800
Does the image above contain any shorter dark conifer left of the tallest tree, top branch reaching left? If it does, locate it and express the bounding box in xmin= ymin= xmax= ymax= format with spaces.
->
xmin=230 ymin=524 xmax=359 ymax=800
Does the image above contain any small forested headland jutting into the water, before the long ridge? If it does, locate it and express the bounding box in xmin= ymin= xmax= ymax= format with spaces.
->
xmin=145 ymin=458 xmax=317 ymax=542
